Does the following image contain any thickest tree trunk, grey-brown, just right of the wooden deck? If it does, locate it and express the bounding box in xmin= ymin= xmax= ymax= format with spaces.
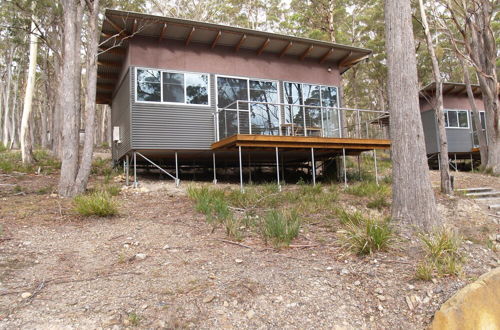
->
xmin=385 ymin=0 xmax=440 ymax=230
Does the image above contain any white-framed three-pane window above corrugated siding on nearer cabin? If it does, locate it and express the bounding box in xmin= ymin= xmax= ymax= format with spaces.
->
xmin=137 ymin=69 xmax=209 ymax=105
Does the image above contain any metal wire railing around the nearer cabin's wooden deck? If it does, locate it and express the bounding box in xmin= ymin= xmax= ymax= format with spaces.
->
xmin=214 ymin=101 xmax=389 ymax=141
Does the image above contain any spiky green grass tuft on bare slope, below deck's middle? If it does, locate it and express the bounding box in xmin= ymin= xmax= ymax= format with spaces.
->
xmin=262 ymin=210 xmax=300 ymax=247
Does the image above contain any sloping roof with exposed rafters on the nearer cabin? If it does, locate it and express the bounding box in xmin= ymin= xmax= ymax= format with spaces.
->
xmin=97 ymin=9 xmax=372 ymax=103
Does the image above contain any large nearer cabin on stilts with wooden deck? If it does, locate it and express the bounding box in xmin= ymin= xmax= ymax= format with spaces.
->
xmin=96 ymin=9 xmax=390 ymax=184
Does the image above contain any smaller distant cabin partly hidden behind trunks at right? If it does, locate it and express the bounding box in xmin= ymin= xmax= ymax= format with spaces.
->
xmin=420 ymin=82 xmax=486 ymax=169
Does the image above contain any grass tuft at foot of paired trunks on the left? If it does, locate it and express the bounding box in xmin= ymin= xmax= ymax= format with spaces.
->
xmin=74 ymin=191 xmax=118 ymax=217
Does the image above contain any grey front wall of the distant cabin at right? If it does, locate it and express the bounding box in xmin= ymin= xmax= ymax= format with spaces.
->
xmin=421 ymin=109 xmax=473 ymax=154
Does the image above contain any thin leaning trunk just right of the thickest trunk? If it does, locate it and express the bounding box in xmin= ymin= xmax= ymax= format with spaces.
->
xmin=418 ymin=0 xmax=453 ymax=195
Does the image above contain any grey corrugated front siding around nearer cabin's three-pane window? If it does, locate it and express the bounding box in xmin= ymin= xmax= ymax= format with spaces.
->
xmin=130 ymin=67 xmax=215 ymax=150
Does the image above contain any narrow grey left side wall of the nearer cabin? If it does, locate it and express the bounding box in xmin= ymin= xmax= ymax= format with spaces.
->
xmin=111 ymin=71 xmax=131 ymax=160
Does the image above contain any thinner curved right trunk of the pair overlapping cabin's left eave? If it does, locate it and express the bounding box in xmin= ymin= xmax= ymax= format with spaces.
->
xmin=73 ymin=0 xmax=99 ymax=194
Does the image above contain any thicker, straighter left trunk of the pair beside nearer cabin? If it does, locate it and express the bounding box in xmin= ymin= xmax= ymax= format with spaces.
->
xmin=58 ymin=0 xmax=82 ymax=197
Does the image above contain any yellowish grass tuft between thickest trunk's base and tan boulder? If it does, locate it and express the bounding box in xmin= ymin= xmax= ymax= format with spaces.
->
xmin=415 ymin=229 xmax=464 ymax=280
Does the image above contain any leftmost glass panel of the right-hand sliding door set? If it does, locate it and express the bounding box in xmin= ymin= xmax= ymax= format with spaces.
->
xmin=283 ymin=82 xmax=304 ymax=135
